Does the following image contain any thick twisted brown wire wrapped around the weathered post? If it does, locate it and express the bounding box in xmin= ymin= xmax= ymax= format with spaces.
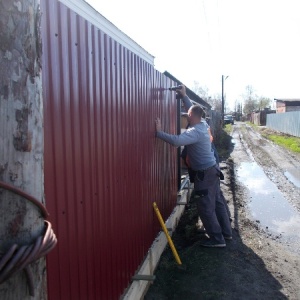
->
xmin=0 ymin=181 xmax=57 ymax=296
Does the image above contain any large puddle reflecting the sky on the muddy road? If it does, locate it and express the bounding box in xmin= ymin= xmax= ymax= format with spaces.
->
xmin=237 ymin=162 xmax=300 ymax=251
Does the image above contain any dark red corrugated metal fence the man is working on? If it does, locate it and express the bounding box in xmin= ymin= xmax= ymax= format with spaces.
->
xmin=41 ymin=0 xmax=177 ymax=300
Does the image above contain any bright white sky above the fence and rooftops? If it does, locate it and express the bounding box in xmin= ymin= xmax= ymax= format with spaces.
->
xmin=86 ymin=0 xmax=300 ymax=108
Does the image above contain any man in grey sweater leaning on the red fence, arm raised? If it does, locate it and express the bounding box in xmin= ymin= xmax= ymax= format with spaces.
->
xmin=155 ymin=86 xmax=232 ymax=247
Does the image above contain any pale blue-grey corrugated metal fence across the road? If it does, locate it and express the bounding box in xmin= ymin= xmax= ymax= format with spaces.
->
xmin=266 ymin=111 xmax=300 ymax=137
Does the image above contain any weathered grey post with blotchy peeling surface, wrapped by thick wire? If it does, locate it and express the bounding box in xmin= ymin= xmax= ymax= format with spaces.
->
xmin=0 ymin=0 xmax=47 ymax=299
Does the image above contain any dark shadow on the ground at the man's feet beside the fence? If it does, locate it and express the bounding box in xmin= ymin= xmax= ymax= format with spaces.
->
xmin=144 ymin=195 xmax=287 ymax=300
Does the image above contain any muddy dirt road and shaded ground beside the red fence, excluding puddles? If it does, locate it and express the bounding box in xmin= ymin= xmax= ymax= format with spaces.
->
xmin=144 ymin=123 xmax=300 ymax=300
